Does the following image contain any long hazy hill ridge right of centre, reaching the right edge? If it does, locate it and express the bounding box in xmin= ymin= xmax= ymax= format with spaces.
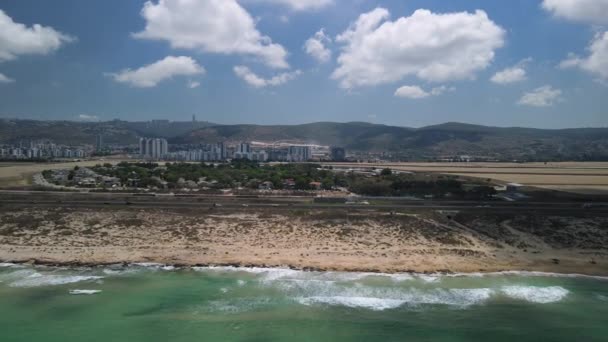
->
xmin=176 ymin=122 xmax=608 ymax=160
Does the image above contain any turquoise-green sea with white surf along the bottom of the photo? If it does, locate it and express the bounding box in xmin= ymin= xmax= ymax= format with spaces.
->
xmin=0 ymin=264 xmax=608 ymax=342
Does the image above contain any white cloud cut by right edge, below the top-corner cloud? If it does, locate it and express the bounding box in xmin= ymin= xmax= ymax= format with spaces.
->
xmin=560 ymin=31 xmax=608 ymax=80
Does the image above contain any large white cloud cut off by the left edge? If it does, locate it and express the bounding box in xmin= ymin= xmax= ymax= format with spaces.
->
xmin=0 ymin=10 xmax=76 ymax=62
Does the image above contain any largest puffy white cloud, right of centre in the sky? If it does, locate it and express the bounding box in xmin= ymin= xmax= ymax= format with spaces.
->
xmin=332 ymin=8 xmax=505 ymax=88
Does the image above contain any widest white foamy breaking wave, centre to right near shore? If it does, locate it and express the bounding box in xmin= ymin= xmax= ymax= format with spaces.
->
xmin=196 ymin=267 xmax=569 ymax=311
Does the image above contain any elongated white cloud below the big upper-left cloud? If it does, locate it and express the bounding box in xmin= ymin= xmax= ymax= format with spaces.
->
xmin=109 ymin=56 xmax=205 ymax=88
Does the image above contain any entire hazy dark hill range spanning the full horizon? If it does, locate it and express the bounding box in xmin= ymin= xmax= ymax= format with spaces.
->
xmin=0 ymin=119 xmax=608 ymax=160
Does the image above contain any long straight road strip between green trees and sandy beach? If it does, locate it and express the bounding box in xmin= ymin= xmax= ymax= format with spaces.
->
xmin=0 ymin=191 xmax=608 ymax=214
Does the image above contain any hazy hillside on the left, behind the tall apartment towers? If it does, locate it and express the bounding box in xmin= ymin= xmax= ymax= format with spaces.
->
xmin=0 ymin=119 xmax=211 ymax=144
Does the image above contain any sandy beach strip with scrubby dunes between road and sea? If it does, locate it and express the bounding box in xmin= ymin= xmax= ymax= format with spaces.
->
xmin=0 ymin=208 xmax=608 ymax=275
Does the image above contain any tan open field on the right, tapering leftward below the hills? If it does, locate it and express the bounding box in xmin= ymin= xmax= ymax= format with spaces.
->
xmin=326 ymin=162 xmax=608 ymax=193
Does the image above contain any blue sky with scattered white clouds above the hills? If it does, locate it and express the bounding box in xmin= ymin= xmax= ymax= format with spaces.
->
xmin=0 ymin=0 xmax=608 ymax=128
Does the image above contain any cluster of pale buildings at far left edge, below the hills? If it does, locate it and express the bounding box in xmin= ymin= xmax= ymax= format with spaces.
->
xmin=0 ymin=141 xmax=90 ymax=160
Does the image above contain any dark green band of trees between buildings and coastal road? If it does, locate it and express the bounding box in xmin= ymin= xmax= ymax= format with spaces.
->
xmin=84 ymin=160 xmax=496 ymax=199
